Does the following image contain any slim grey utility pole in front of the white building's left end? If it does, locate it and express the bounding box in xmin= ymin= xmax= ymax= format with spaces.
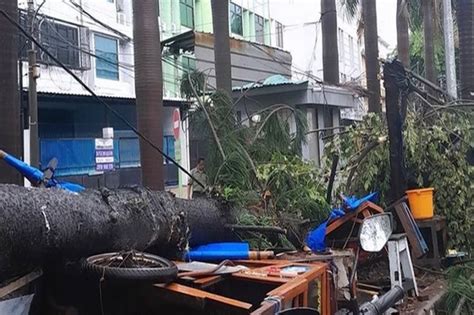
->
xmin=28 ymin=0 xmax=39 ymax=167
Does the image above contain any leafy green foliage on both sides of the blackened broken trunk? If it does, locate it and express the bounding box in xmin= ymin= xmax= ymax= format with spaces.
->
xmin=326 ymin=110 xmax=474 ymax=250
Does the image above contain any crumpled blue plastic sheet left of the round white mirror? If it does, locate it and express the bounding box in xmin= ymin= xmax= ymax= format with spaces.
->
xmin=306 ymin=192 xmax=377 ymax=253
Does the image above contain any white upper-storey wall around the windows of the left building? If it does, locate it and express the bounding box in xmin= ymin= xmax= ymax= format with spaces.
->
xmin=19 ymin=0 xmax=135 ymax=97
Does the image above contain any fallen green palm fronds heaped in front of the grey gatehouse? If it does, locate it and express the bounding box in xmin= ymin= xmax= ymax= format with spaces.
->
xmin=182 ymin=70 xmax=329 ymax=245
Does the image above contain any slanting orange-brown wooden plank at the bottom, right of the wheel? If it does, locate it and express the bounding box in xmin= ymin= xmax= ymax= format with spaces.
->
xmin=154 ymin=283 xmax=252 ymax=311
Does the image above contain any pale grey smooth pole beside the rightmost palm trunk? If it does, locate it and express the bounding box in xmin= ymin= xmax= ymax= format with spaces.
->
xmin=443 ymin=0 xmax=458 ymax=99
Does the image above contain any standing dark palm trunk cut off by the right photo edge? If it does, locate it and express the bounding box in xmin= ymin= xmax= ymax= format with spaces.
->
xmin=456 ymin=0 xmax=474 ymax=99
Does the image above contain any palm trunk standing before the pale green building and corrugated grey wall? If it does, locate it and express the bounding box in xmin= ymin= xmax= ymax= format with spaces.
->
xmin=211 ymin=0 xmax=232 ymax=95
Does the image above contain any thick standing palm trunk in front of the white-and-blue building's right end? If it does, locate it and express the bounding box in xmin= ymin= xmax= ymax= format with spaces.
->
xmin=133 ymin=0 xmax=164 ymax=190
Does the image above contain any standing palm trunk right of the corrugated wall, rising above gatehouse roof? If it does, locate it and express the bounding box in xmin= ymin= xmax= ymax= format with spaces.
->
xmin=321 ymin=0 xmax=339 ymax=84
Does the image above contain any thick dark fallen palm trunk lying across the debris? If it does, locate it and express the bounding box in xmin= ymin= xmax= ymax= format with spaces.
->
xmin=0 ymin=185 xmax=233 ymax=282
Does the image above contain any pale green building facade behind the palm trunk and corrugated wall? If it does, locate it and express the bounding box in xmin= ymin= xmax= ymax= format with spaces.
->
xmin=160 ymin=0 xmax=291 ymax=98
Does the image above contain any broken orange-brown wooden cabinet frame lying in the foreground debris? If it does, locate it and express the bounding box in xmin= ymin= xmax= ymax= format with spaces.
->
xmin=154 ymin=260 xmax=332 ymax=315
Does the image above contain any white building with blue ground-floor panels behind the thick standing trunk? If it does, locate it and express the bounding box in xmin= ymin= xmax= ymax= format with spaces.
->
xmin=19 ymin=0 xmax=189 ymax=187
